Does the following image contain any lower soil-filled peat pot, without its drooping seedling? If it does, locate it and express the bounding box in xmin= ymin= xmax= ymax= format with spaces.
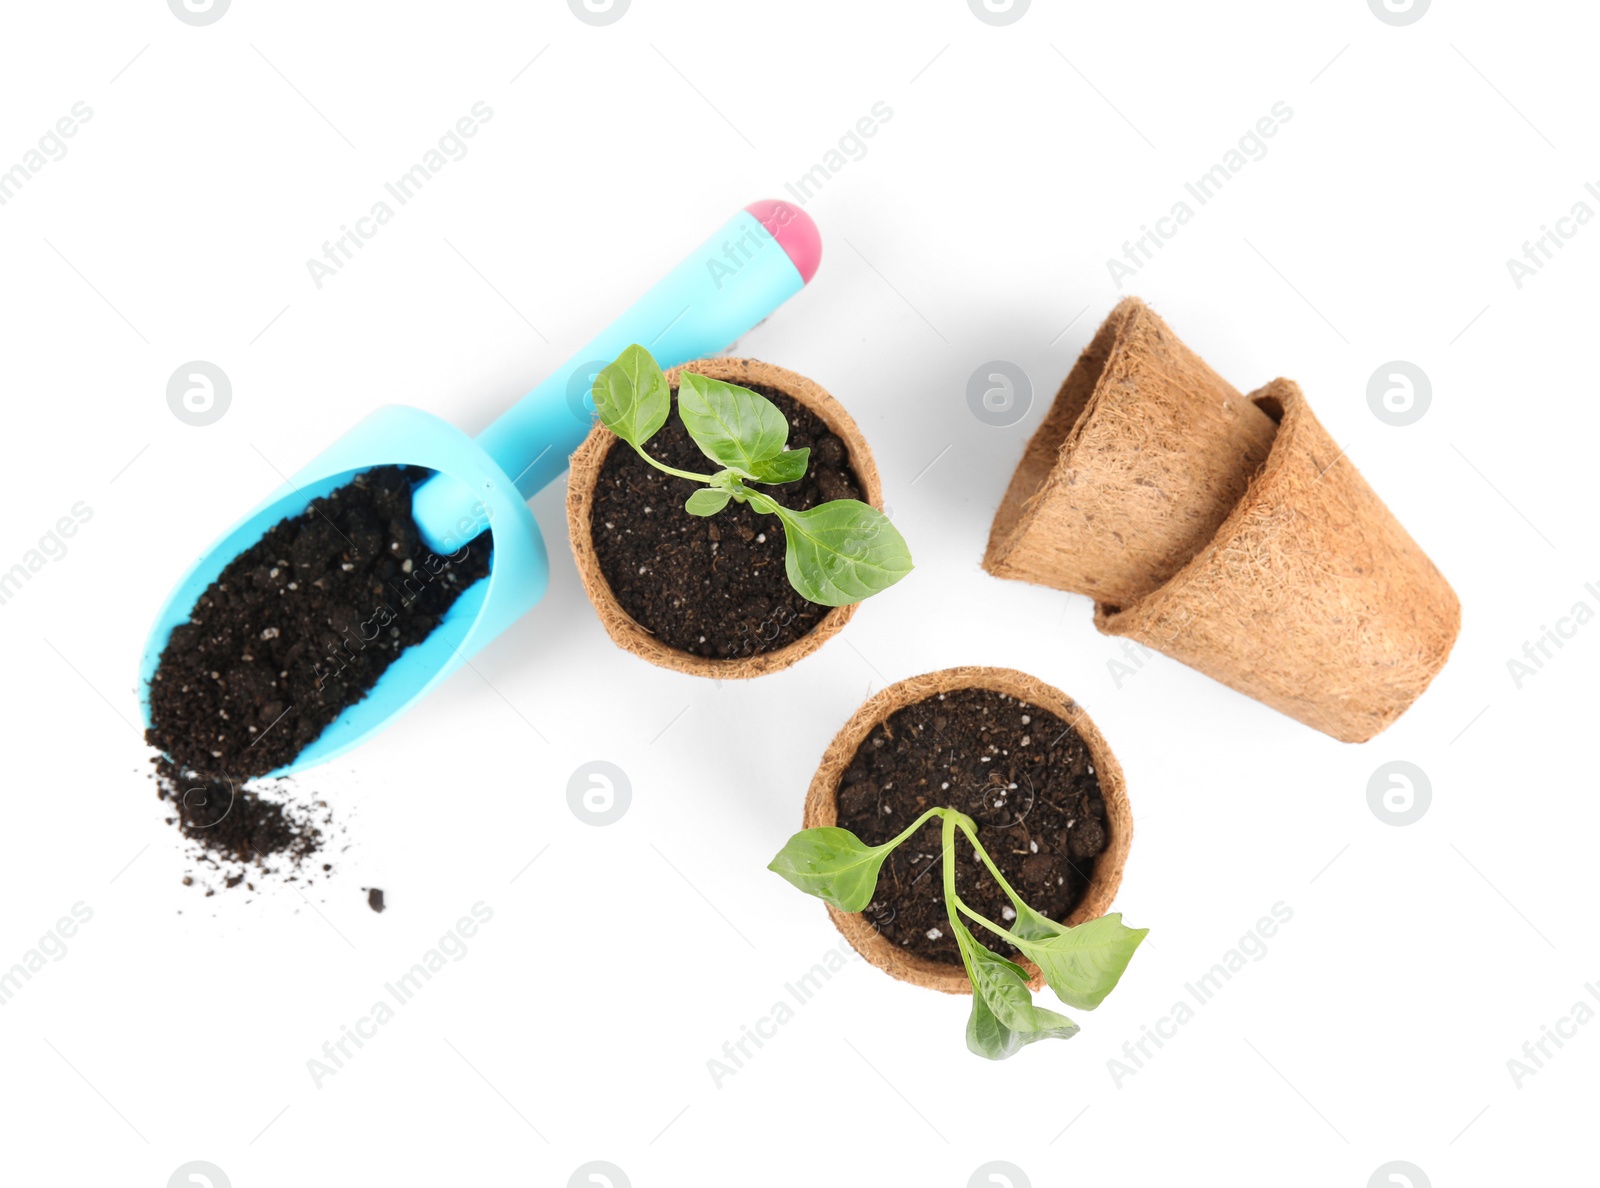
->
xmin=803 ymin=668 xmax=1133 ymax=994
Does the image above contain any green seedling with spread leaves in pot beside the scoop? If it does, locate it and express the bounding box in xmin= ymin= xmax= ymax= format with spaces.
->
xmin=594 ymin=344 xmax=912 ymax=607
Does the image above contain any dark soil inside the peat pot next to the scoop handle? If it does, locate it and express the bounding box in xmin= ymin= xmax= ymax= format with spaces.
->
xmin=589 ymin=384 xmax=861 ymax=660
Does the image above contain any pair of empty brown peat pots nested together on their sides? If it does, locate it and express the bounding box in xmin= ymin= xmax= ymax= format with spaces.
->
xmin=984 ymin=298 xmax=1461 ymax=743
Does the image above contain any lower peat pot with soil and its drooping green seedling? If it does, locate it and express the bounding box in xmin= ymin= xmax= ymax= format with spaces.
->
xmin=770 ymin=668 xmax=1146 ymax=1060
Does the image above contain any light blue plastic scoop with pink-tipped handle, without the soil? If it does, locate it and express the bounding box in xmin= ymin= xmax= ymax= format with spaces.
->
xmin=139 ymin=200 xmax=821 ymax=775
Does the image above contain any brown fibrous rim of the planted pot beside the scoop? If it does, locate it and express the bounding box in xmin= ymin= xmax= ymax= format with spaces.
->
xmin=566 ymin=357 xmax=883 ymax=680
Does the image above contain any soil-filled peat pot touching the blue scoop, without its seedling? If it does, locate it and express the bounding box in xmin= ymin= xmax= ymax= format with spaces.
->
xmin=566 ymin=359 xmax=883 ymax=679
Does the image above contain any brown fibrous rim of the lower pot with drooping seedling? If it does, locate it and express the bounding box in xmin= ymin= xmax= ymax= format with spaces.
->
xmin=803 ymin=666 xmax=1133 ymax=994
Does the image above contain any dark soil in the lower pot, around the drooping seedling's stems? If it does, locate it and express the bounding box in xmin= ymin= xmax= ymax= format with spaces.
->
xmin=838 ymin=688 xmax=1107 ymax=965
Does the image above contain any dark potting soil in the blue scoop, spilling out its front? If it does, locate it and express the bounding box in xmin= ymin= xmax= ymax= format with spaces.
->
xmin=146 ymin=466 xmax=490 ymax=885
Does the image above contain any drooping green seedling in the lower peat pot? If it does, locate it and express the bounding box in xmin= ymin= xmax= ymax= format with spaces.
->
xmin=766 ymin=809 xmax=1149 ymax=1060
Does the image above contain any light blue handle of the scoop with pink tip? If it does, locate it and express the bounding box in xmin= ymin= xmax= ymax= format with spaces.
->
xmin=411 ymin=199 xmax=822 ymax=554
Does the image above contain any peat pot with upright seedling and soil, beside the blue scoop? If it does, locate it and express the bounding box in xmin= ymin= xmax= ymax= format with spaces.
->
xmin=566 ymin=346 xmax=912 ymax=677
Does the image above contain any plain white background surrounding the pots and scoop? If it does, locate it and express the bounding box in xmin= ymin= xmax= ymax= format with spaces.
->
xmin=0 ymin=0 xmax=1600 ymax=1188
